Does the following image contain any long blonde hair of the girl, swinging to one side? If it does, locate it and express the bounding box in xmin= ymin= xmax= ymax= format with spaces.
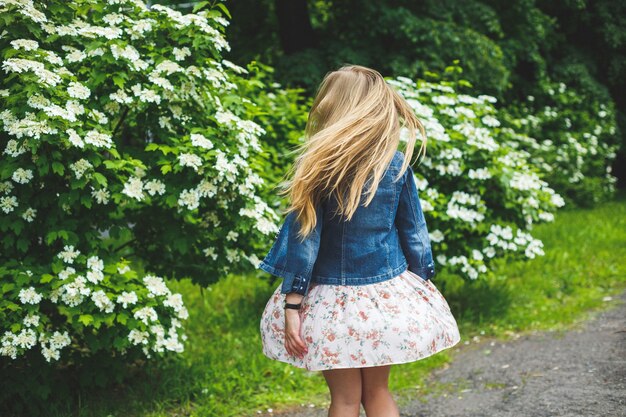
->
xmin=279 ymin=65 xmax=426 ymax=238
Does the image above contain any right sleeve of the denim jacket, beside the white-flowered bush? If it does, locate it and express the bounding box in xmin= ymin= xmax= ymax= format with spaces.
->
xmin=395 ymin=165 xmax=435 ymax=280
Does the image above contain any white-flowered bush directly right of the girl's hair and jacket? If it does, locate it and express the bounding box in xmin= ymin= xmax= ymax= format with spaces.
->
xmin=388 ymin=77 xmax=564 ymax=279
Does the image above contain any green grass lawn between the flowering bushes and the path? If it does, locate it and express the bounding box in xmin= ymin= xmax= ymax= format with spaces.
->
xmin=46 ymin=195 xmax=626 ymax=417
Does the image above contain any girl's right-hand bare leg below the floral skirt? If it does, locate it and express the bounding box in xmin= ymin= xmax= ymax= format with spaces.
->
xmin=361 ymin=365 xmax=400 ymax=417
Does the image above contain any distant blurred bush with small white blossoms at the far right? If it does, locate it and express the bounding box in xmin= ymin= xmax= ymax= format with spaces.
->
xmin=503 ymin=80 xmax=619 ymax=206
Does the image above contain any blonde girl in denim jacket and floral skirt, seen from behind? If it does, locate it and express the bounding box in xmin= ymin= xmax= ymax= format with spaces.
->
xmin=258 ymin=65 xmax=460 ymax=417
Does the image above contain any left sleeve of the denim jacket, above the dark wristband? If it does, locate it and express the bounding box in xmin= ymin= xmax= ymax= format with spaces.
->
xmin=257 ymin=204 xmax=324 ymax=296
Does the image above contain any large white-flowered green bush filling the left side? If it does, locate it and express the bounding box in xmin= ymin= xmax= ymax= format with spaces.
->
xmin=0 ymin=0 xmax=277 ymax=361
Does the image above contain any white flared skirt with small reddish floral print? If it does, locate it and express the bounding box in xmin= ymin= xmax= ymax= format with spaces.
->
xmin=260 ymin=270 xmax=461 ymax=371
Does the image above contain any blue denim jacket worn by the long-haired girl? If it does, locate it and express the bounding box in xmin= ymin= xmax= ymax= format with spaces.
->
xmin=257 ymin=151 xmax=435 ymax=295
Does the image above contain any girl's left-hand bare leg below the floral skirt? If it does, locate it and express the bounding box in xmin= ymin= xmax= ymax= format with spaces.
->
xmin=322 ymin=368 xmax=361 ymax=417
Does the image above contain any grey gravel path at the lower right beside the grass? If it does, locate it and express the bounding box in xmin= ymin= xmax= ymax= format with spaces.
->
xmin=256 ymin=292 xmax=626 ymax=417
